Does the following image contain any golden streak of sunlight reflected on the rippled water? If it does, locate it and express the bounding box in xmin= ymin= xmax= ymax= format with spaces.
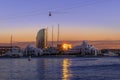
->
xmin=62 ymin=59 xmax=72 ymax=80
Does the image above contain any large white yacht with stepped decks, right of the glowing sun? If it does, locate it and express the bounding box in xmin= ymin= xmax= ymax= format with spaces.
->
xmin=65 ymin=41 xmax=101 ymax=56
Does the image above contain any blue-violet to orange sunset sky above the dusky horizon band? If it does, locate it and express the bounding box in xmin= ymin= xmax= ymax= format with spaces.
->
xmin=0 ymin=0 xmax=120 ymax=43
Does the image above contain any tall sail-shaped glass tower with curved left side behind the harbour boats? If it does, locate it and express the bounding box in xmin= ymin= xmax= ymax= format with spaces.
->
xmin=36 ymin=28 xmax=47 ymax=49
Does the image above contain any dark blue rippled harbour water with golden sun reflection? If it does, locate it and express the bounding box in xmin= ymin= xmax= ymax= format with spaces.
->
xmin=0 ymin=57 xmax=120 ymax=80
